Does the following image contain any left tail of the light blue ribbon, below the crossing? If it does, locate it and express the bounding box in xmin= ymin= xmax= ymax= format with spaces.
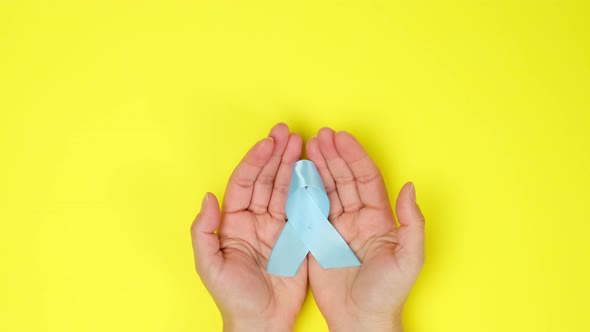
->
xmin=266 ymin=222 xmax=309 ymax=277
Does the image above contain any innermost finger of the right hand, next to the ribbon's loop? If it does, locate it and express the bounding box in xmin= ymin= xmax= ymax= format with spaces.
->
xmin=305 ymin=137 xmax=344 ymax=219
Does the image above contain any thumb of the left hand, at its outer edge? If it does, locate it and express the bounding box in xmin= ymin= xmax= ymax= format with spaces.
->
xmin=191 ymin=193 xmax=223 ymax=274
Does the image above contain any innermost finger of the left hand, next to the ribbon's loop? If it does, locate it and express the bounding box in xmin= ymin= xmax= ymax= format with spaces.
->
xmin=268 ymin=134 xmax=303 ymax=220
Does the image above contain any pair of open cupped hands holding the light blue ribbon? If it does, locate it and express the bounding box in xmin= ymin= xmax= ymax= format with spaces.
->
xmin=191 ymin=123 xmax=424 ymax=331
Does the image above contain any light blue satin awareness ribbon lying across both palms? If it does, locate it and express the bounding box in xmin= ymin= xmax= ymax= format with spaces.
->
xmin=267 ymin=160 xmax=361 ymax=276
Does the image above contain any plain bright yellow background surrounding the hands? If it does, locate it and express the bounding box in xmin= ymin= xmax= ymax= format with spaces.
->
xmin=0 ymin=0 xmax=590 ymax=331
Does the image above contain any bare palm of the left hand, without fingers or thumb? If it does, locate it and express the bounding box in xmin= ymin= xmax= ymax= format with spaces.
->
xmin=217 ymin=212 xmax=307 ymax=315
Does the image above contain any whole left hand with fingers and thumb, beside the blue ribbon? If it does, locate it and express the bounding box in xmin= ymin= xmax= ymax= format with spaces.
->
xmin=192 ymin=124 xmax=307 ymax=325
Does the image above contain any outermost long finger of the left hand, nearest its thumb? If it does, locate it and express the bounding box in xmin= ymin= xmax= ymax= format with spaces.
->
xmin=223 ymin=137 xmax=274 ymax=213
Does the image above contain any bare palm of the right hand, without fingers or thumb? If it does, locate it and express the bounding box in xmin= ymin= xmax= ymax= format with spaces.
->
xmin=309 ymin=208 xmax=413 ymax=313
